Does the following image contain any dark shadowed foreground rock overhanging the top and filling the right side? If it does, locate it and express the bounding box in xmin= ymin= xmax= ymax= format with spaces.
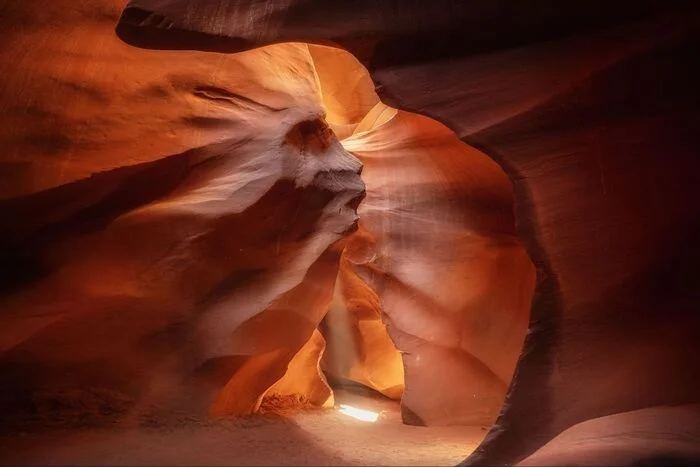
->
xmin=119 ymin=0 xmax=700 ymax=465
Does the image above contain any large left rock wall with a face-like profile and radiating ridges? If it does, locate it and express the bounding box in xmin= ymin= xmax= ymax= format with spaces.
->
xmin=0 ymin=1 xmax=364 ymax=424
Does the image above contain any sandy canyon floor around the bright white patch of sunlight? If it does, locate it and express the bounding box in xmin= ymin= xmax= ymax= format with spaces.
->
xmin=0 ymin=391 xmax=486 ymax=466
